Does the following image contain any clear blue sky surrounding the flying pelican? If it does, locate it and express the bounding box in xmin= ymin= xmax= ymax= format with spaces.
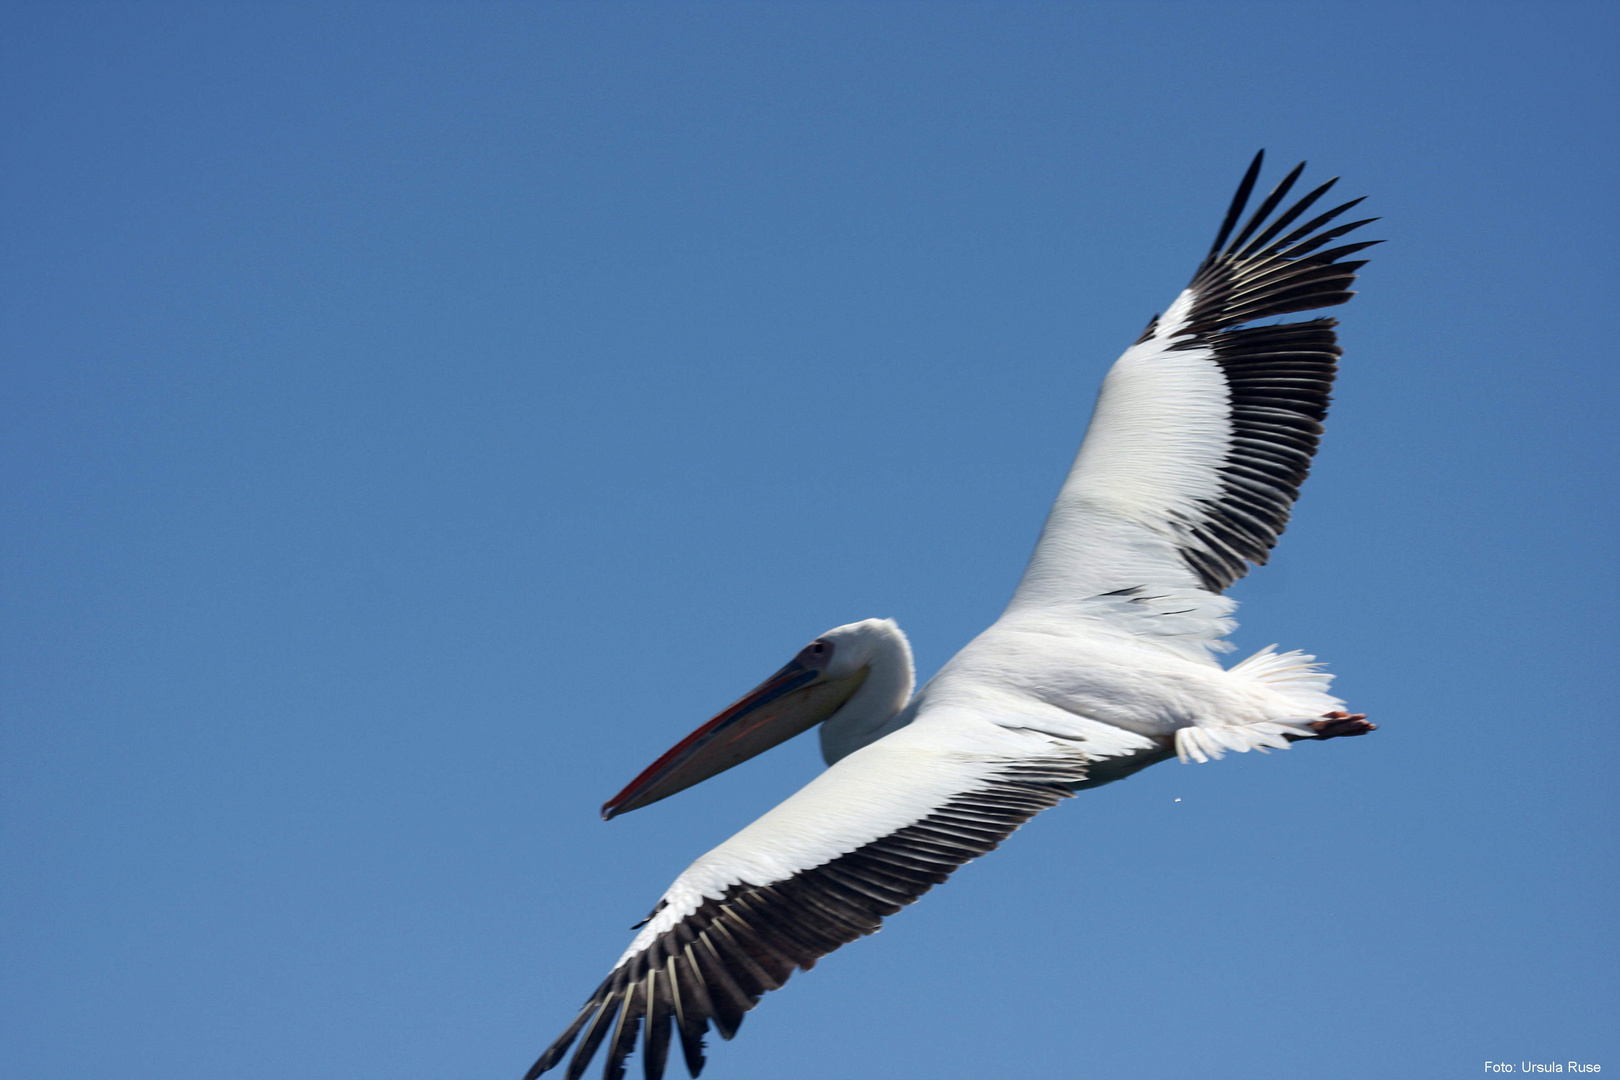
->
xmin=0 ymin=3 xmax=1620 ymax=1080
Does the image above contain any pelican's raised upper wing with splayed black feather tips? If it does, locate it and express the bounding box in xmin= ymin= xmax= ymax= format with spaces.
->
xmin=1009 ymin=154 xmax=1379 ymax=610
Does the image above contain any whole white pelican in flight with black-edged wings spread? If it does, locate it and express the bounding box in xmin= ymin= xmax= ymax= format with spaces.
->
xmin=525 ymin=152 xmax=1377 ymax=1080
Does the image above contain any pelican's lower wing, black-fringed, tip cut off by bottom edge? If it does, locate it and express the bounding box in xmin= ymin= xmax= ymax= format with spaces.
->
xmin=525 ymin=729 xmax=1085 ymax=1080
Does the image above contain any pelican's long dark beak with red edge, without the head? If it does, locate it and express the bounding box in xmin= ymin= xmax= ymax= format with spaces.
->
xmin=603 ymin=659 xmax=870 ymax=821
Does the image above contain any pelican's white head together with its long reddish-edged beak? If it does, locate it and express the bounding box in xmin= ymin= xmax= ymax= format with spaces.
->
xmin=603 ymin=619 xmax=914 ymax=819
